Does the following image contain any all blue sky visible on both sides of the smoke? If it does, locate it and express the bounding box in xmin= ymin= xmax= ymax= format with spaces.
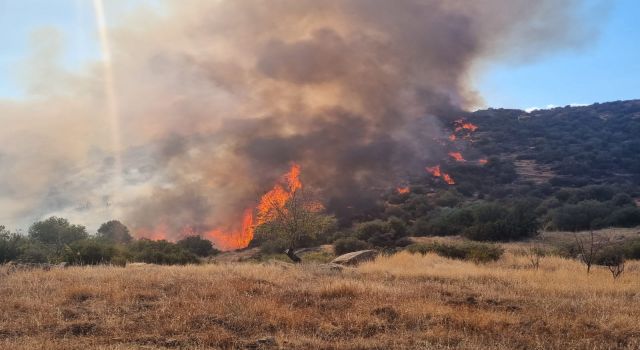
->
xmin=0 ymin=0 xmax=640 ymax=109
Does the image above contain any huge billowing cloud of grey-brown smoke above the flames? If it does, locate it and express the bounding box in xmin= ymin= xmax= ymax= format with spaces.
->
xmin=0 ymin=0 xmax=601 ymax=241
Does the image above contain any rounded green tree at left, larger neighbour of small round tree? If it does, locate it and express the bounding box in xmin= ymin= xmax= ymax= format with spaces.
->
xmin=29 ymin=216 xmax=88 ymax=255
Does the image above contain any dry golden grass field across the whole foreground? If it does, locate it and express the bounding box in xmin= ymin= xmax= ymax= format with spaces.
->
xmin=0 ymin=253 xmax=640 ymax=349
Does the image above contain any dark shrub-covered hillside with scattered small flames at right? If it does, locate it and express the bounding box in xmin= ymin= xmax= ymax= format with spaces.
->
xmin=378 ymin=100 xmax=640 ymax=240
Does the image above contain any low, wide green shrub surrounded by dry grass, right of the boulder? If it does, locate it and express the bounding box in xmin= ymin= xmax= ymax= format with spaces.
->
xmin=406 ymin=242 xmax=504 ymax=263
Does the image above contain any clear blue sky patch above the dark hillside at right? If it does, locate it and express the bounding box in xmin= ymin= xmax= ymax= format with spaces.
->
xmin=475 ymin=0 xmax=640 ymax=109
